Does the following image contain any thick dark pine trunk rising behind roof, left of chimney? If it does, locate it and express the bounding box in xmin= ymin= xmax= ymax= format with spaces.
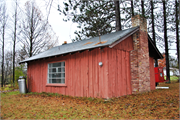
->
xmin=114 ymin=0 xmax=121 ymax=31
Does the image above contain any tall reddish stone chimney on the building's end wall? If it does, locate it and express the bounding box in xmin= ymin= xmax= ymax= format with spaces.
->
xmin=130 ymin=15 xmax=150 ymax=93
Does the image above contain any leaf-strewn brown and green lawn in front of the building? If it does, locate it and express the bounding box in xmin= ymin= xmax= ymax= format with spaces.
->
xmin=0 ymin=82 xmax=179 ymax=119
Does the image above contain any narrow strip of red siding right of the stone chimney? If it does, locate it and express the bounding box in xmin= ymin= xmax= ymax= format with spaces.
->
xmin=149 ymin=57 xmax=155 ymax=90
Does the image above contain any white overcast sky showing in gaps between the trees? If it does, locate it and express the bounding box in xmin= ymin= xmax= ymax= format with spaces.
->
xmin=7 ymin=0 xmax=176 ymax=57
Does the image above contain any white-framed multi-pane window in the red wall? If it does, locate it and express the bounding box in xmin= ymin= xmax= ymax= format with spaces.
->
xmin=47 ymin=62 xmax=65 ymax=84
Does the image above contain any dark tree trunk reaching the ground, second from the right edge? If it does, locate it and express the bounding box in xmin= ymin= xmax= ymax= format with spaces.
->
xmin=162 ymin=0 xmax=170 ymax=83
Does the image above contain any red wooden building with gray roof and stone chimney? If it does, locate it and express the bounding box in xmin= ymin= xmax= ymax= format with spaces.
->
xmin=20 ymin=15 xmax=163 ymax=98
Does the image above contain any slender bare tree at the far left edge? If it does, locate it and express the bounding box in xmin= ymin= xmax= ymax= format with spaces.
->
xmin=0 ymin=2 xmax=8 ymax=87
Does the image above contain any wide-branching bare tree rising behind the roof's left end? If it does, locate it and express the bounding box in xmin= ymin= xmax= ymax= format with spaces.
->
xmin=21 ymin=2 xmax=57 ymax=57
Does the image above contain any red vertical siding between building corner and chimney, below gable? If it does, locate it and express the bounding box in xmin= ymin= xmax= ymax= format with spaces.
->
xmin=108 ymin=49 xmax=132 ymax=97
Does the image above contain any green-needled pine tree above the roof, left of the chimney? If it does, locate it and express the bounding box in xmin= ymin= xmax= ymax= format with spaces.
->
xmin=58 ymin=0 xmax=128 ymax=41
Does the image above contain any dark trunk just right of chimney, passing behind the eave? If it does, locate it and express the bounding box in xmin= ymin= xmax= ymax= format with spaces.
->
xmin=150 ymin=0 xmax=158 ymax=67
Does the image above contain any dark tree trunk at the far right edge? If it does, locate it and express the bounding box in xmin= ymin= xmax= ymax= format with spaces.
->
xmin=175 ymin=0 xmax=179 ymax=64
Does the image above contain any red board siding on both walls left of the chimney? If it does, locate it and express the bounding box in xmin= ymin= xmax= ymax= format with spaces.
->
xmin=28 ymin=37 xmax=133 ymax=98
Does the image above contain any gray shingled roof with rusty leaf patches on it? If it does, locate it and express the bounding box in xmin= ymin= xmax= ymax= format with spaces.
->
xmin=20 ymin=27 xmax=139 ymax=63
